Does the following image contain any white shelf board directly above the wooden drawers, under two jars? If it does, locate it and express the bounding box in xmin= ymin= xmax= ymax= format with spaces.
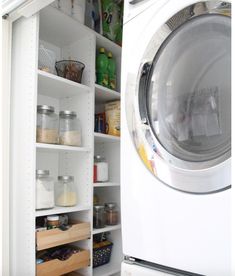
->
xmin=35 ymin=205 xmax=91 ymax=217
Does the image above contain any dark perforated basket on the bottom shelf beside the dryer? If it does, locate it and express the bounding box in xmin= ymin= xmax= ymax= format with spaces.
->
xmin=93 ymin=241 xmax=113 ymax=267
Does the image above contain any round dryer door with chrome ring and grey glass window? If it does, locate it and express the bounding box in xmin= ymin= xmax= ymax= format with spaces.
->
xmin=127 ymin=2 xmax=231 ymax=193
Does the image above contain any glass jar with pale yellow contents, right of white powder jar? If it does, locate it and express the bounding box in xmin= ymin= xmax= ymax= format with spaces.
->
xmin=55 ymin=175 xmax=77 ymax=207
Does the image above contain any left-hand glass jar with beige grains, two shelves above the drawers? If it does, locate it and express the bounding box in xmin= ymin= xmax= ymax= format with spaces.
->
xmin=36 ymin=105 xmax=59 ymax=144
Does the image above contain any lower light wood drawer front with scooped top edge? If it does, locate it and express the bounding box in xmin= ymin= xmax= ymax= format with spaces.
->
xmin=36 ymin=250 xmax=90 ymax=276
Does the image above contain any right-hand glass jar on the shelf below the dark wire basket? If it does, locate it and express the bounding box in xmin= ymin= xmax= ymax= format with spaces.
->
xmin=59 ymin=110 xmax=82 ymax=147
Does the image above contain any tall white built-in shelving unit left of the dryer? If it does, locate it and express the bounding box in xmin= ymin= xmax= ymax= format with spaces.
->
xmin=10 ymin=2 xmax=123 ymax=276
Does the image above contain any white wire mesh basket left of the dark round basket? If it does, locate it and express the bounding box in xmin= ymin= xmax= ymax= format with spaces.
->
xmin=38 ymin=45 xmax=56 ymax=74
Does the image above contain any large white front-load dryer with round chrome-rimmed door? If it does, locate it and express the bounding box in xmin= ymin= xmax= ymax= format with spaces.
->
xmin=121 ymin=0 xmax=232 ymax=276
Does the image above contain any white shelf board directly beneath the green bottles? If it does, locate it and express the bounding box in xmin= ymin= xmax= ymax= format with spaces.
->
xmin=95 ymin=84 xmax=121 ymax=103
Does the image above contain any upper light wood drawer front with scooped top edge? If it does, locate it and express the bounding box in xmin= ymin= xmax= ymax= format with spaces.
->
xmin=36 ymin=221 xmax=91 ymax=251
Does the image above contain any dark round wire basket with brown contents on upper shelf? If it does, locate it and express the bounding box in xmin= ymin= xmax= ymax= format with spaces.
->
xmin=55 ymin=60 xmax=85 ymax=83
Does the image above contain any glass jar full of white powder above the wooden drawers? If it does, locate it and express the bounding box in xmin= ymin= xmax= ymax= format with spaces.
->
xmin=36 ymin=170 xmax=55 ymax=210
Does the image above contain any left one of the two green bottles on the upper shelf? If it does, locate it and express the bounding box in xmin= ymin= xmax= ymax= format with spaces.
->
xmin=96 ymin=48 xmax=109 ymax=87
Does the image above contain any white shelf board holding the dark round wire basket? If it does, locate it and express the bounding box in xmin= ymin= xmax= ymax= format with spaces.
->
xmin=38 ymin=70 xmax=90 ymax=99
